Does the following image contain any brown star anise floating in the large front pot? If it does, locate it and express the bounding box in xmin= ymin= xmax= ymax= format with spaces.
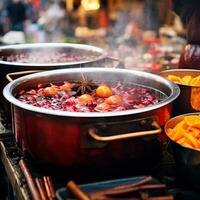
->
xmin=73 ymin=79 xmax=98 ymax=95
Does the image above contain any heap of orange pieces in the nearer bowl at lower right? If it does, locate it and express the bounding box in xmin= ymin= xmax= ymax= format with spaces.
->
xmin=167 ymin=115 xmax=200 ymax=150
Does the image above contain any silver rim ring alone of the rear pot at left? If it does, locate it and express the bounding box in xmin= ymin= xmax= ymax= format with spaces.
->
xmin=0 ymin=43 xmax=107 ymax=67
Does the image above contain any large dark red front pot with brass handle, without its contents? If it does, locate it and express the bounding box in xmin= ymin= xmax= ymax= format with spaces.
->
xmin=3 ymin=68 xmax=179 ymax=166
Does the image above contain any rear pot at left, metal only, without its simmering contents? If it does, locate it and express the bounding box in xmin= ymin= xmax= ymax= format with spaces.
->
xmin=0 ymin=43 xmax=112 ymax=119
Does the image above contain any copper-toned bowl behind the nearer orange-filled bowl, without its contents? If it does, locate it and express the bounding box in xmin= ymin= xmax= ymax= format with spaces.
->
xmin=160 ymin=69 xmax=200 ymax=116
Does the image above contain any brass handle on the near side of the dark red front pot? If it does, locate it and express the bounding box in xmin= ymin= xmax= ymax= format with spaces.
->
xmin=88 ymin=121 xmax=162 ymax=142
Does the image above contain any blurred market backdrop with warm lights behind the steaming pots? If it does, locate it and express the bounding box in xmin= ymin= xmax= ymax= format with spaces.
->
xmin=0 ymin=0 xmax=185 ymax=71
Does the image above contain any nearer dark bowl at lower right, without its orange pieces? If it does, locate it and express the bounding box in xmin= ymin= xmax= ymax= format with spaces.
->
xmin=164 ymin=113 xmax=200 ymax=189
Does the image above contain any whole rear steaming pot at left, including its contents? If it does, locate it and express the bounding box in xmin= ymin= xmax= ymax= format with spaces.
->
xmin=0 ymin=43 xmax=119 ymax=123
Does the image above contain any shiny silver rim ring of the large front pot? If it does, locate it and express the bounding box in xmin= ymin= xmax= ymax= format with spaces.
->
xmin=3 ymin=67 xmax=180 ymax=118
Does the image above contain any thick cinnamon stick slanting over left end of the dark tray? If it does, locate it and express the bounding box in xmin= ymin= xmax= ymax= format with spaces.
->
xmin=67 ymin=181 xmax=90 ymax=200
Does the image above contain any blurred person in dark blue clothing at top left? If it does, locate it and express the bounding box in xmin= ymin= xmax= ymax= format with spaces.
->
xmin=6 ymin=0 xmax=26 ymax=31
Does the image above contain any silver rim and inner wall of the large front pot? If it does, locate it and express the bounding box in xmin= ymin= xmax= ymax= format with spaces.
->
xmin=3 ymin=68 xmax=180 ymax=118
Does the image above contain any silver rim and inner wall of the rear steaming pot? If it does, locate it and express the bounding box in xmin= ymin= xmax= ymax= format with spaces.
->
xmin=0 ymin=43 xmax=106 ymax=69
